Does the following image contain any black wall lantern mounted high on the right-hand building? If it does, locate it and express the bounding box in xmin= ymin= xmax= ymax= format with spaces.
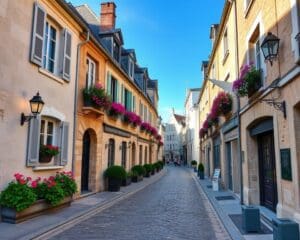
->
xmin=261 ymin=32 xmax=280 ymax=66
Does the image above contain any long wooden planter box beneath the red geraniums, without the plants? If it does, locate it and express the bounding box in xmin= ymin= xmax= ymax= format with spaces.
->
xmin=1 ymin=197 xmax=72 ymax=223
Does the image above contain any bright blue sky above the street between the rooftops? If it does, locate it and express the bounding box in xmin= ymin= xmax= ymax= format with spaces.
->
xmin=71 ymin=0 xmax=224 ymax=122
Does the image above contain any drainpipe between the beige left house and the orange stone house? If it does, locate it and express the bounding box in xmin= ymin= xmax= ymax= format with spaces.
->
xmin=72 ymin=30 xmax=90 ymax=173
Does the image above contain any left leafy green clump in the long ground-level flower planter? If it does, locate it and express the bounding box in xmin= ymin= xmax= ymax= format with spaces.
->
xmin=0 ymin=182 xmax=37 ymax=212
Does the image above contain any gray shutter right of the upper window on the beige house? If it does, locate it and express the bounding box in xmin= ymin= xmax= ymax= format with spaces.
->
xmin=62 ymin=29 xmax=72 ymax=81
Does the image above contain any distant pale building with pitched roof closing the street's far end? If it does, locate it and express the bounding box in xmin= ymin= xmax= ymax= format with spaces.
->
xmin=164 ymin=110 xmax=185 ymax=162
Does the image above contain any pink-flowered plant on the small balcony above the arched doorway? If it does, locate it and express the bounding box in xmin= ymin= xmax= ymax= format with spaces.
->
xmin=83 ymin=83 xmax=111 ymax=109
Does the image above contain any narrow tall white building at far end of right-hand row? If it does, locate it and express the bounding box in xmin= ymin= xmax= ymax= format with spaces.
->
xmin=184 ymin=88 xmax=201 ymax=165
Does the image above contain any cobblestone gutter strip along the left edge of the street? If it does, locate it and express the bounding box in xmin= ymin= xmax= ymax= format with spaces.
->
xmin=31 ymin=169 xmax=167 ymax=240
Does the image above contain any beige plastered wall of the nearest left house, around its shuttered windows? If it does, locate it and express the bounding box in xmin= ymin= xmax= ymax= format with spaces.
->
xmin=0 ymin=0 xmax=81 ymax=189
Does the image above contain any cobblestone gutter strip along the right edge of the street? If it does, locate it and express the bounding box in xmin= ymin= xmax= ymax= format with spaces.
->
xmin=192 ymin=173 xmax=232 ymax=240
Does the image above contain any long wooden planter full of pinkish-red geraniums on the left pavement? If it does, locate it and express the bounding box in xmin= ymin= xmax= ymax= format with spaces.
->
xmin=0 ymin=172 xmax=77 ymax=223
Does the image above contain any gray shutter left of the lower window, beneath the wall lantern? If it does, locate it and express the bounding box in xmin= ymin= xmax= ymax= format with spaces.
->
xmin=26 ymin=116 xmax=41 ymax=166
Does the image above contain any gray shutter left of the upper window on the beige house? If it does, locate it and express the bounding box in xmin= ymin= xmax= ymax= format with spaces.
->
xmin=30 ymin=3 xmax=46 ymax=67
